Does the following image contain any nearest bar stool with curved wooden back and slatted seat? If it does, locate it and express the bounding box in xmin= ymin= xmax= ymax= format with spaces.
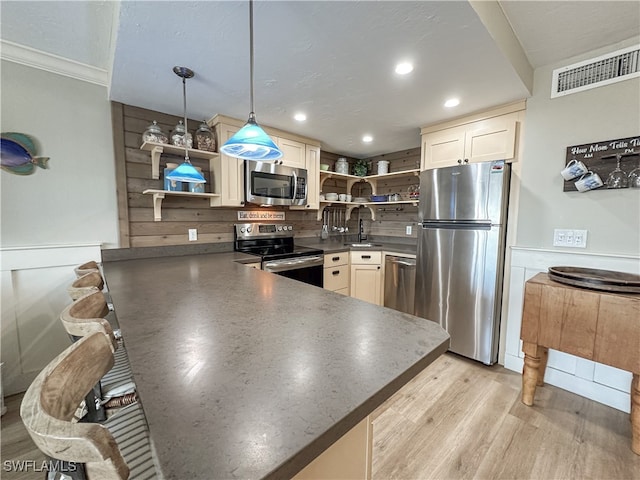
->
xmin=20 ymin=332 xmax=159 ymax=480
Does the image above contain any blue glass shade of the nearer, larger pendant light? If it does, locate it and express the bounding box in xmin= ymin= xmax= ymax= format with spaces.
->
xmin=220 ymin=114 xmax=282 ymax=161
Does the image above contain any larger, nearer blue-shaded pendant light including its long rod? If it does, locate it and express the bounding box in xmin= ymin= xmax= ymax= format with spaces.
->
xmin=220 ymin=0 xmax=282 ymax=160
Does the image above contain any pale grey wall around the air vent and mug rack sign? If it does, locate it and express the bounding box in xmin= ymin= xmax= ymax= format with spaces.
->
xmin=517 ymin=39 xmax=640 ymax=255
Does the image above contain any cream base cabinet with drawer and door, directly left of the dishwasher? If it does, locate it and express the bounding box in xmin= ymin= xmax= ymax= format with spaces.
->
xmin=349 ymin=251 xmax=382 ymax=305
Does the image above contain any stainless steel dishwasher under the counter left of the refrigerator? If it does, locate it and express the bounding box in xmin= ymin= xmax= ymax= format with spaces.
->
xmin=384 ymin=255 xmax=416 ymax=315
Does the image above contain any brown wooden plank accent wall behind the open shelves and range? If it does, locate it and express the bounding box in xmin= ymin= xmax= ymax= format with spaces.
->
xmin=112 ymin=102 xmax=420 ymax=248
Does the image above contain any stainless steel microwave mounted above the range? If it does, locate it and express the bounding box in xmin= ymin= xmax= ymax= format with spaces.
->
xmin=244 ymin=160 xmax=307 ymax=205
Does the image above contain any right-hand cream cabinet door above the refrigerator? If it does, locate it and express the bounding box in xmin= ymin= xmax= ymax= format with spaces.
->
xmin=464 ymin=115 xmax=516 ymax=162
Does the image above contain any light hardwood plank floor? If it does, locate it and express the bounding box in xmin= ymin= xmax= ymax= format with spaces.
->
xmin=1 ymin=353 xmax=640 ymax=480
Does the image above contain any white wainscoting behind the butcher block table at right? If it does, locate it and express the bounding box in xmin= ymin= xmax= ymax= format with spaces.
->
xmin=504 ymin=247 xmax=640 ymax=412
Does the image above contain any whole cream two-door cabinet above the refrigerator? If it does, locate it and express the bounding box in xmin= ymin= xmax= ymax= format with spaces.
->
xmin=420 ymin=102 xmax=524 ymax=170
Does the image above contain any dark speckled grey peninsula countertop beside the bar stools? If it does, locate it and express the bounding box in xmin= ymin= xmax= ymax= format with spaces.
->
xmin=103 ymin=253 xmax=449 ymax=480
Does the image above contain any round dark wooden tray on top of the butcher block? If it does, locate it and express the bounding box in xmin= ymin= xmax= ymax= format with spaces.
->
xmin=549 ymin=267 xmax=640 ymax=293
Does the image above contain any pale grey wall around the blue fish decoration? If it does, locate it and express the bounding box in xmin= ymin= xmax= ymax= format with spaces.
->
xmin=0 ymin=61 xmax=118 ymax=248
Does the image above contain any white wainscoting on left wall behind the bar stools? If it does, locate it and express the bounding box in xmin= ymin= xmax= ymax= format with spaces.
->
xmin=0 ymin=244 xmax=101 ymax=395
